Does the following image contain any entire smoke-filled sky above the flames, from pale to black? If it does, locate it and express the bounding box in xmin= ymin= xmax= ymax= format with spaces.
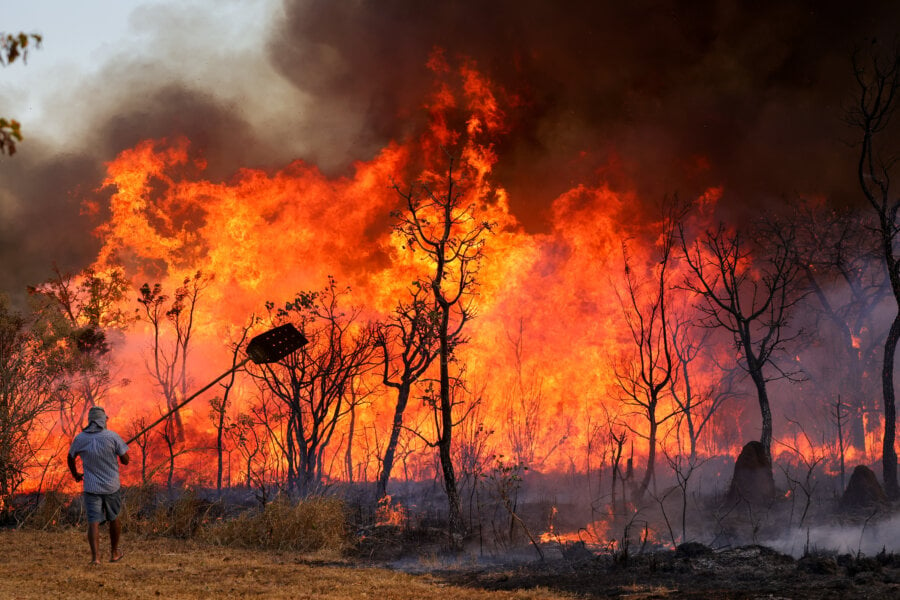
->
xmin=0 ymin=0 xmax=900 ymax=304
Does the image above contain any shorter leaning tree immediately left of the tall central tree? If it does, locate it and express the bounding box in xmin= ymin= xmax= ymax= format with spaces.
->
xmin=375 ymin=281 xmax=439 ymax=499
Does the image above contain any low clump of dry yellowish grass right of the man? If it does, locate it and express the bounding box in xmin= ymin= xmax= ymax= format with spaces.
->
xmin=200 ymin=497 xmax=350 ymax=553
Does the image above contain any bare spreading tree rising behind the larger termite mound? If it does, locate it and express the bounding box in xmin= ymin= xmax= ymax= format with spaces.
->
xmin=681 ymin=222 xmax=803 ymax=464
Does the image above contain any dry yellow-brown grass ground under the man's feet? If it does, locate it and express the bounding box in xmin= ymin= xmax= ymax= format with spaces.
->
xmin=0 ymin=527 xmax=568 ymax=600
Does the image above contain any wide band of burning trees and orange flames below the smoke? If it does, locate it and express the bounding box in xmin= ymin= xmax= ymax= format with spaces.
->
xmin=0 ymin=10 xmax=900 ymax=596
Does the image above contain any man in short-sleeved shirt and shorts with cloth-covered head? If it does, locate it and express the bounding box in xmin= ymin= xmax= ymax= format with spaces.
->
xmin=68 ymin=406 xmax=129 ymax=565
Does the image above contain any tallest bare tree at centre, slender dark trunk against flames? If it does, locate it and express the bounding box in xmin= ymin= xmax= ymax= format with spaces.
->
xmin=394 ymin=157 xmax=492 ymax=545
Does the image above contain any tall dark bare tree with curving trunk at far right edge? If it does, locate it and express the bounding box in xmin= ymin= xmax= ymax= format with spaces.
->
xmin=846 ymin=44 xmax=900 ymax=499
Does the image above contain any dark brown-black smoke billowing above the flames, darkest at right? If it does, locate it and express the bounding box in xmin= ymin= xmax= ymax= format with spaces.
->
xmin=269 ymin=0 xmax=898 ymax=225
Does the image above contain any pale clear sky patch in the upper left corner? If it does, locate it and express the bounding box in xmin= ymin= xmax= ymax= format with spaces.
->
xmin=0 ymin=0 xmax=279 ymax=143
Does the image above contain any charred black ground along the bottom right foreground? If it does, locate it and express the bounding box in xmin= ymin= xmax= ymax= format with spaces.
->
xmin=431 ymin=544 xmax=900 ymax=600
